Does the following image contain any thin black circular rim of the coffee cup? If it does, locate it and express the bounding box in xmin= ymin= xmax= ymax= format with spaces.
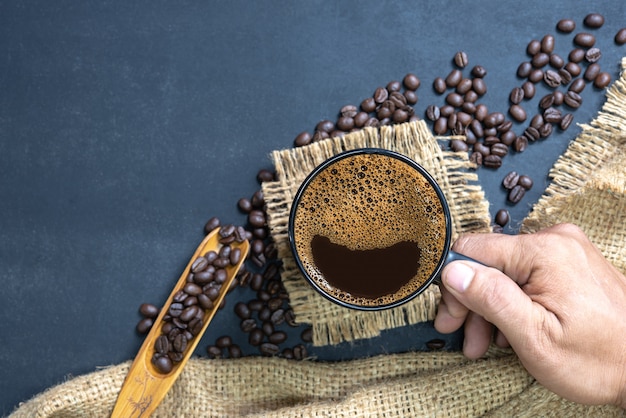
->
xmin=288 ymin=147 xmax=452 ymax=311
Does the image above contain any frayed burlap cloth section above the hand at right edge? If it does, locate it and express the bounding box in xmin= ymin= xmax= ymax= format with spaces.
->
xmin=521 ymin=58 xmax=626 ymax=272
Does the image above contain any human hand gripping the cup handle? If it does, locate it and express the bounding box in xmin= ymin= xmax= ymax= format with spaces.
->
xmin=435 ymin=224 xmax=626 ymax=408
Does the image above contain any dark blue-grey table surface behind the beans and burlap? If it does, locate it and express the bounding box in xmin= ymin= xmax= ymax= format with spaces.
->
xmin=0 ymin=0 xmax=626 ymax=415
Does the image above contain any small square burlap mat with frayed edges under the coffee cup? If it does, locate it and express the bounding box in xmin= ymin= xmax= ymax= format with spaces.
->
xmin=263 ymin=121 xmax=490 ymax=345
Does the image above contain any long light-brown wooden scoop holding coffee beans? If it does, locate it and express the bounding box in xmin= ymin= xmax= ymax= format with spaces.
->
xmin=111 ymin=228 xmax=250 ymax=418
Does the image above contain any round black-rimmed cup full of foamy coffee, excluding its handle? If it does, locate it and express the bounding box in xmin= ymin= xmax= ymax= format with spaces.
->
xmin=289 ymin=148 xmax=456 ymax=310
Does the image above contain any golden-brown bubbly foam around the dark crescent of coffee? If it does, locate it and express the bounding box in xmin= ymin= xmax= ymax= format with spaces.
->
xmin=293 ymin=153 xmax=446 ymax=307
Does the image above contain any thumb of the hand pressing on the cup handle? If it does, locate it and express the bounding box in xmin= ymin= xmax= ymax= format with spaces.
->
xmin=441 ymin=261 xmax=534 ymax=346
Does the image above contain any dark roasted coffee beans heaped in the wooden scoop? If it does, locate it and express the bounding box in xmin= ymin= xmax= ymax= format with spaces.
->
xmin=149 ymin=225 xmax=247 ymax=373
